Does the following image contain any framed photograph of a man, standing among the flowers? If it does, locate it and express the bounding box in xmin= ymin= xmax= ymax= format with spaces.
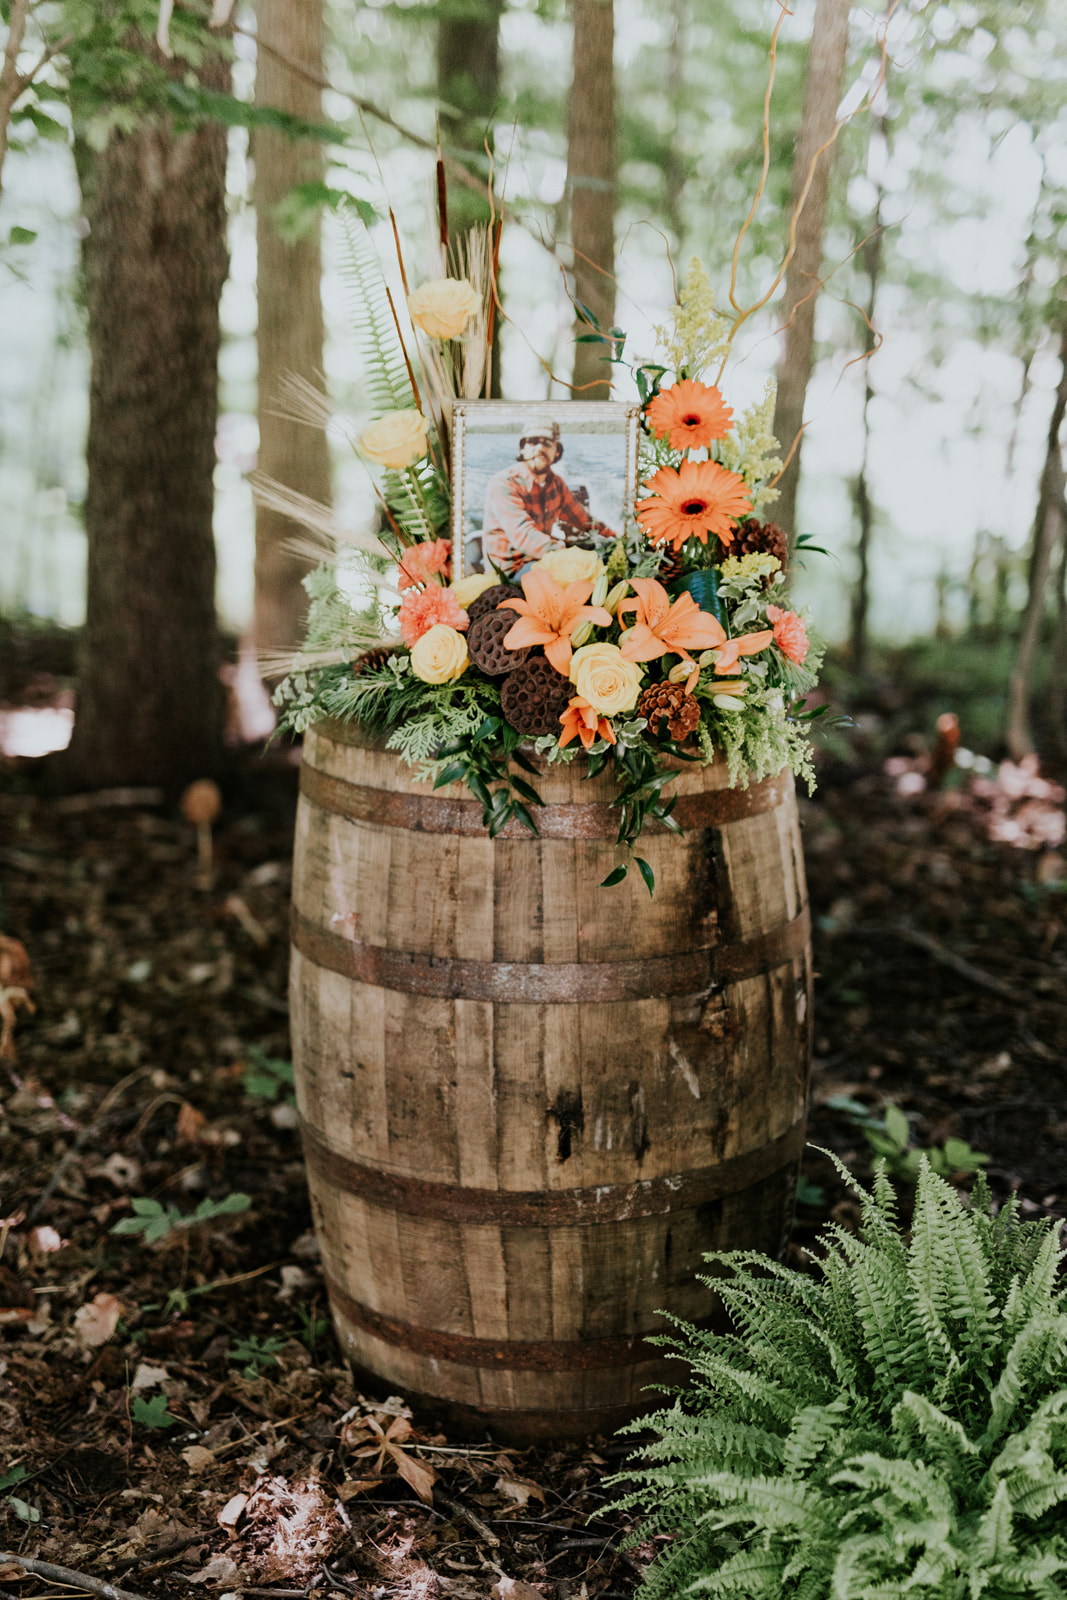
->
xmin=453 ymin=400 xmax=640 ymax=578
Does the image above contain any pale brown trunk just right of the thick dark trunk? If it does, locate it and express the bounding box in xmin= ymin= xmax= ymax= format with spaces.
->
xmin=253 ymin=0 xmax=330 ymax=650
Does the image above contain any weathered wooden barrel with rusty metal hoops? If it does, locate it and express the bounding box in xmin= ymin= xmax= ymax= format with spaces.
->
xmin=291 ymin=723 xmax=811 ymax=1440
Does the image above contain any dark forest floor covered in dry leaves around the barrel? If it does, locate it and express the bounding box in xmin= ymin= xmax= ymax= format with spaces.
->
xmin=0 ymin=729 xmax=1067 ymax=1600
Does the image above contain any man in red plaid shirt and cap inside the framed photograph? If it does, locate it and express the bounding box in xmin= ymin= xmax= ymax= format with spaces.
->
xmin=482 ymin=416 xmax=614 ymax=576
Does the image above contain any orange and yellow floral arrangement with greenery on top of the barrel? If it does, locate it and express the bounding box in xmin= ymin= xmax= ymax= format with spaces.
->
xmin=268 ymin=229 xmax=821 ymax=890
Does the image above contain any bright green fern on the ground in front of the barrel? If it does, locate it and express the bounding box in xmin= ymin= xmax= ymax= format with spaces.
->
xmin=616 ymin=1162 xmax=1067 ymax=1600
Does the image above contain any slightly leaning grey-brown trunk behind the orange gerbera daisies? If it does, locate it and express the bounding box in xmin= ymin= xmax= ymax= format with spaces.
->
xmin=774 ymin=0 xmax=849 ymax=534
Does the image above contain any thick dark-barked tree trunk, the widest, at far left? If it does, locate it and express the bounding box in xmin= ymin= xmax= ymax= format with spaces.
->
xmin=66 ymin=43 xmax=229 ymax=786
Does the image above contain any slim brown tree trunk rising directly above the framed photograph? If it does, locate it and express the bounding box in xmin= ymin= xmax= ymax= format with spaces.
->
xmin=566 ymin=0 xmax=617 ymax=400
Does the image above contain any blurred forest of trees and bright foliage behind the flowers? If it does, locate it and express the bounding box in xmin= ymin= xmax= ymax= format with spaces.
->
xmin=0 ymin=0 xmax=1067 ymax=778
